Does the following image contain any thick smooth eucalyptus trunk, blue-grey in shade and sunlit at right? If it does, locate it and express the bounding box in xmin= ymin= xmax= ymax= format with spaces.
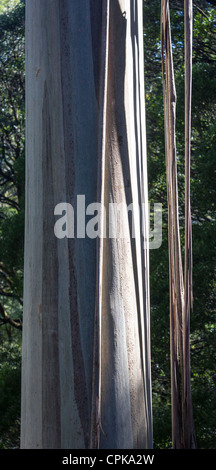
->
xmin=21 ymin=0 xmax=152 ymax=449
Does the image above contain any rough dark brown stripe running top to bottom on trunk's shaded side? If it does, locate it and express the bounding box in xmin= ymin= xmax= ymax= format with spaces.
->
xmin=60 ymin=0 xmax=90 ymax=448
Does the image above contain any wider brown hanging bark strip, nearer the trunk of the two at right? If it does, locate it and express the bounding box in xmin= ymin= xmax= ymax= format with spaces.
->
xmin=161 ymin=0 xmax=183 ymax=448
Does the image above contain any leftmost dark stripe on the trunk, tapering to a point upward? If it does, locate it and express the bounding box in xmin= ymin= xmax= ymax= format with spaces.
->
xmin=42 ymin=82 xmax=61 ymax=449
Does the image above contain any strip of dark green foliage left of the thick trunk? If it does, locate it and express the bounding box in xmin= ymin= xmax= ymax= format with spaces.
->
xmin=0 ymin=0 xmax=25 ymax=448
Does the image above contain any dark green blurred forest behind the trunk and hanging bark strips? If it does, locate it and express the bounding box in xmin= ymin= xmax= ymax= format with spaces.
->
xmin=0 ymin=0 xmax=216 ymax=449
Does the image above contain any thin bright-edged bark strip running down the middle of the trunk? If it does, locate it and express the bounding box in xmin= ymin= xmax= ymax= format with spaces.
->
xmin=90 ymin=0 xmax=110 ymax=449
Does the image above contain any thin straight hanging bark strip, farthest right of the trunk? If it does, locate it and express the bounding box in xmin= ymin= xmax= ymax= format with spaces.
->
xmin=183 ymin=0 xmax=196 ymax=448
